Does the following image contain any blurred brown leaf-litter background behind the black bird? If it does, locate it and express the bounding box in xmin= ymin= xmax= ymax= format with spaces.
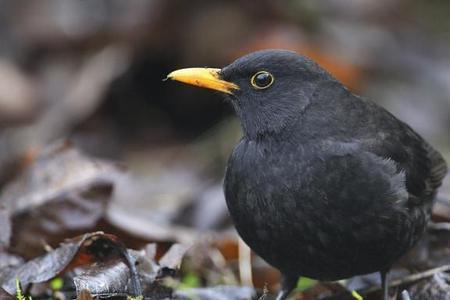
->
xmin=0 ymin=0 xmax=450 ymax=298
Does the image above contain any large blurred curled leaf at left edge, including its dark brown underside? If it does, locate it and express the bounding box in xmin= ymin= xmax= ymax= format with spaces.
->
xmin=0 ymin=143 xmax=119 ymax=258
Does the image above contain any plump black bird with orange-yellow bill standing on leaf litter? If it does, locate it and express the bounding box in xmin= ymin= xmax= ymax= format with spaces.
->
xmin=168 ymin=50 xmax=447 ymax=300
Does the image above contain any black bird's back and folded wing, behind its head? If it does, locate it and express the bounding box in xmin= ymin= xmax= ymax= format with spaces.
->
xmin=295 ymin=82 xmax=447 ymax=209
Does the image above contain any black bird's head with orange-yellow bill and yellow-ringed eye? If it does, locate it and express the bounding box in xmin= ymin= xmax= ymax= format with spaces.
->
xmin=167 ymin=50 xmax=332 ymax=139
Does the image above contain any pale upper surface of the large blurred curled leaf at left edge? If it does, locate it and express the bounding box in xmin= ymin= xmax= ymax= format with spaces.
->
xmin=0 ymin=142 xmax=117 ymax=214
